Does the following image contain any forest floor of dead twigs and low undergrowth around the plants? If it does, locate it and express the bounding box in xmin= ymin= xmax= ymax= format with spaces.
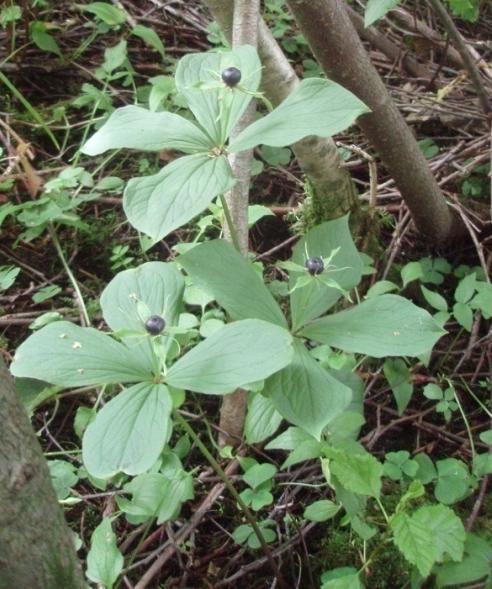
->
xmin=0 ymin=0 xmax=492 ymax=589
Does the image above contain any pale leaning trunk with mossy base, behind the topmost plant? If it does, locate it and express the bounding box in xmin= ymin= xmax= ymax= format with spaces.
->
xmin=206 ymin=0 xmax=361 ymax=228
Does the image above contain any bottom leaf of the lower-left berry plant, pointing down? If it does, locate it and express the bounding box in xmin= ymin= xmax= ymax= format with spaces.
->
xmin=82 ymin=383 xmax=172 ymax=479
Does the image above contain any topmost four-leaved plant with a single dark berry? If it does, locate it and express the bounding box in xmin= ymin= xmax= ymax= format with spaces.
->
xmin=82 ymin=45 xmax=368 ymax=241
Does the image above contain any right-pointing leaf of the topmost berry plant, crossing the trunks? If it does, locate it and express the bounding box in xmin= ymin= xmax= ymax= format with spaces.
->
xmin=229 ymin=78 xmax=369 ymax=152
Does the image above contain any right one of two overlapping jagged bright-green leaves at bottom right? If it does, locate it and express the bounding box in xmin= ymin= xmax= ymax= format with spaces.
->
xmin=412 ymin=505 xmax=466 ymax=562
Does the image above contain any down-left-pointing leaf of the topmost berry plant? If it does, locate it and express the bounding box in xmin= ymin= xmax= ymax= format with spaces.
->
xmin=123 ymin=154 xmax=234 ymax=241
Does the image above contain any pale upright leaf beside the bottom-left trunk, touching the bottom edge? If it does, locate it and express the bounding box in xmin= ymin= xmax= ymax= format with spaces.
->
xmin=87 ymin=518 xmax=123 ymax=589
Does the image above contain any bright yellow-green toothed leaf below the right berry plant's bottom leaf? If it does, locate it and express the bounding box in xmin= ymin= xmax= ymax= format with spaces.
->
xmin=327 ymin=448 xmax=383 ymax=498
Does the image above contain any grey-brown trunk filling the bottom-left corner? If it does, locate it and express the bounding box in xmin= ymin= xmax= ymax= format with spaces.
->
xmin=0 ymin=358 xmax=85 ymax=589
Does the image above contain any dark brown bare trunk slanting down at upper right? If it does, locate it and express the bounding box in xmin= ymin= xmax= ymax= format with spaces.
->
xmin=287 ymin=0 xmax=460 ymax=244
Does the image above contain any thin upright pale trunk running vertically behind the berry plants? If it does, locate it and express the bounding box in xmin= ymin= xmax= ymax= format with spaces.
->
xmin=219 ymin=0 xmax=260 ymax=446
